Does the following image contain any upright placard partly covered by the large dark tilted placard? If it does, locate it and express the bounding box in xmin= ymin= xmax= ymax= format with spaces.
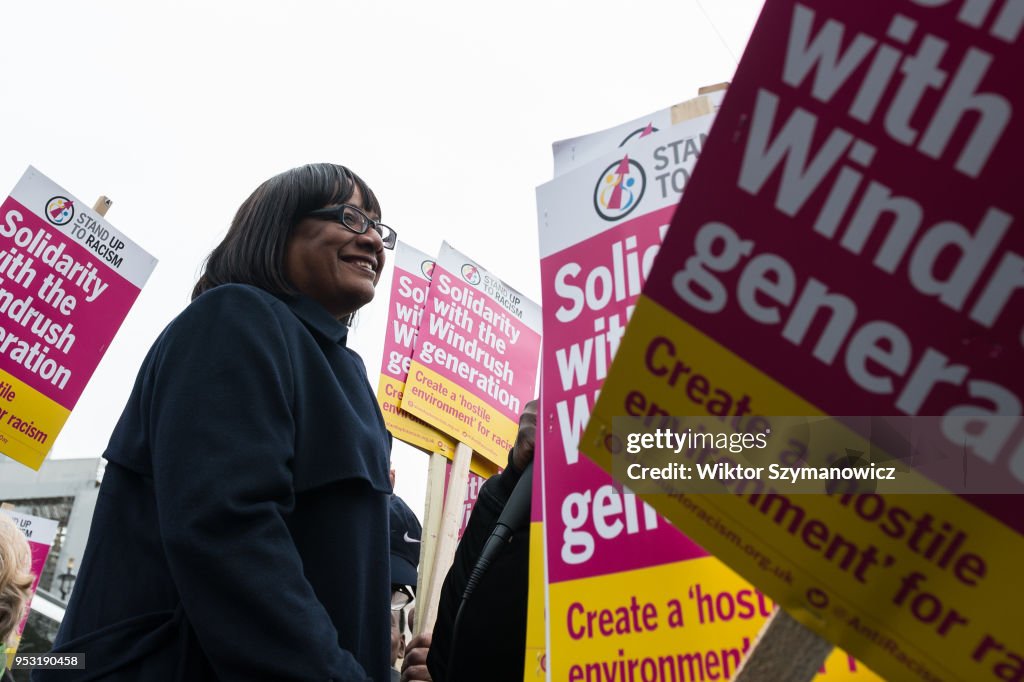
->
xmin=525 ymin=116 xmax=873 ymax=680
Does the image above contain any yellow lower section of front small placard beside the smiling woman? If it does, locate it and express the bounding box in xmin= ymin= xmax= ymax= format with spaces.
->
xmin=401 ymin=360 xmax=519 ymax=467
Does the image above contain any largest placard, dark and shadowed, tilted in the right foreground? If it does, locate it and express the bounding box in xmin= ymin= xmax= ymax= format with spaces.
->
xmin=581 ymin=0 xmax=1024 ymax=680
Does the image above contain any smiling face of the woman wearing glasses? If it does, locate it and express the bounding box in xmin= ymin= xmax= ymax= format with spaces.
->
xmin=285 ymin=187 xmax=384 ymax=319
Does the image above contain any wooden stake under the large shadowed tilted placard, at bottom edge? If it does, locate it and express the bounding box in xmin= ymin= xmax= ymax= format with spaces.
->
xmin=732 ymin=608 xmax=833 ymax=682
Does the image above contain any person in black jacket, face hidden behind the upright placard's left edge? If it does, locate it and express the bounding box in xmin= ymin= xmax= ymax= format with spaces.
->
xmin=402 ymin=400 xmax=537 ymax=682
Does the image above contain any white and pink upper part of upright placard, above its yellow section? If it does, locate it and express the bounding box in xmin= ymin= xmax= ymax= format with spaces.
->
xmin=538 ymin=116 xmax=714 ymax=583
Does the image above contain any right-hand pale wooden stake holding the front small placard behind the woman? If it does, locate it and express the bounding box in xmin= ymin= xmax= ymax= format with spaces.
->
xmin=416 ymin=442 xmax=473 ymax=635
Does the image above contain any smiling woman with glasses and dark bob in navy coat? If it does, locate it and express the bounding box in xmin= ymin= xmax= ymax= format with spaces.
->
xmin=39 ymin=164 xmax=396 ymax=682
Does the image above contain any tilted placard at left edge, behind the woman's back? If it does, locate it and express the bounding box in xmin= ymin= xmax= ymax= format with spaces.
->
xmin=0 ymin=167 xmax=157 ymax=469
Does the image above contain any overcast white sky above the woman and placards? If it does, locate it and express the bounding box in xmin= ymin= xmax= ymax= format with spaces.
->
xmin=0 ymin=0 xmax=763 ymax=513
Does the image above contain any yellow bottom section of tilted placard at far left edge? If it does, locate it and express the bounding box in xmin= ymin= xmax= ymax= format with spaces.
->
xmin=0 ymin=372 xmax=71 ymax=471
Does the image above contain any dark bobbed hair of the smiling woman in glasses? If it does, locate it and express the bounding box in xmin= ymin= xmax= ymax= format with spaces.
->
xmin=191 ymin=164 xmax=381 ymax=299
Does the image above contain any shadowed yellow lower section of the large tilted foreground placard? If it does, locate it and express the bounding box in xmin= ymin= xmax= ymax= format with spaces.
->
xmin=585 ymin=297 xmax=1024 ymax=682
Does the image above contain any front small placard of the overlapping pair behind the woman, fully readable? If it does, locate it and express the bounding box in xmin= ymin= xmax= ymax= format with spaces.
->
xmin=401 ymin=243 xmax=541 ymax=467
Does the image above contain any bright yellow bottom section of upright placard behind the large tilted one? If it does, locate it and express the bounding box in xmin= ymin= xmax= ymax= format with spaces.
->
xmin=550 ymin=557 xmax=880 ymax=682
